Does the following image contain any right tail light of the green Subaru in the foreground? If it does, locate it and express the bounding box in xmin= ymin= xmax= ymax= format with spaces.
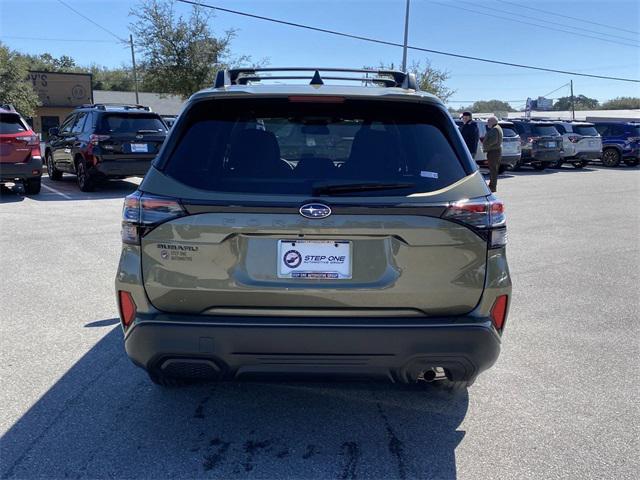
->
xmin=441 ymin=195 xmax=507 ymax=248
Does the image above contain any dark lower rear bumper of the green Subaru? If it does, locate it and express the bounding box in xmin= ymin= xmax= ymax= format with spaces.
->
xmin=125 ymin=314 xmax=500 ymax=382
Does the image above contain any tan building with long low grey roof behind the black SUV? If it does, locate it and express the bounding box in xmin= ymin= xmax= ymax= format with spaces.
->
xmin=27 ymin=71 xmax=184 ymax=140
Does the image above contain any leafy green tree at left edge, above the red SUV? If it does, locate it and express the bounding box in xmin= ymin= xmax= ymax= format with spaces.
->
xmin=0 ymin=43 xmax=40 ymax=117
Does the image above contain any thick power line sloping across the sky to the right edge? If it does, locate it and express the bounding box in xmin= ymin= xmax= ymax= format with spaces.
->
xmin=177 ymin=0 xmax=640 ymax=83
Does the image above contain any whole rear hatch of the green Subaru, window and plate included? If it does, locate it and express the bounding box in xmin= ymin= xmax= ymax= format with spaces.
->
xmin=141 ymin=95 xmax=488 ymax=317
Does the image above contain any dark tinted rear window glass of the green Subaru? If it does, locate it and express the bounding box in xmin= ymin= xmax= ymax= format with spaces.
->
xmin=164 ymin=99 xmax=466 ymax=196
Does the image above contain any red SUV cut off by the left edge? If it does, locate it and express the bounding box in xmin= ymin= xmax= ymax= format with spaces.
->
xmin=0 ymin=105 xmax=42 ymax=195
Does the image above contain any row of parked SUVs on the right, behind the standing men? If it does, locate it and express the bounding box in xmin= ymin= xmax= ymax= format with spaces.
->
xmin=456 ymin=119 xmax=640 ymax=172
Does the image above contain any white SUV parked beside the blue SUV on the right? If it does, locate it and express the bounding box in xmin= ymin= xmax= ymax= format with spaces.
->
xmin=553 ymin=122 xmax=602 ymax=168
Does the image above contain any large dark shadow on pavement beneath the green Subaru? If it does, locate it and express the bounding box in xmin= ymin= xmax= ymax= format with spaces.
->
xmin=0 ymin=319 xmax=468 ymax=479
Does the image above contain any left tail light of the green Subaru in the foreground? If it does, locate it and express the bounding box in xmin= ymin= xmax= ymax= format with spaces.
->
xmin=122 ymin=191 xmax=186 ymax=245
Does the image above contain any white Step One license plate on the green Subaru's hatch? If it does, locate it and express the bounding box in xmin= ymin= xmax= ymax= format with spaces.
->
xmin=278 ymin=240 xmax=351 ymax=280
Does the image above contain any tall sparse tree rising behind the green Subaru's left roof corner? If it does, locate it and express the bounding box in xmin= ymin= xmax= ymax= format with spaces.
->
xmin=131 ymin=0 xmax=234 ymax=98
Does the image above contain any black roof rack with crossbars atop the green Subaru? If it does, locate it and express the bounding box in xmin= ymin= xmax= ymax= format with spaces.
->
xmin=214 ymin=67 xmax=418 ymax=90
